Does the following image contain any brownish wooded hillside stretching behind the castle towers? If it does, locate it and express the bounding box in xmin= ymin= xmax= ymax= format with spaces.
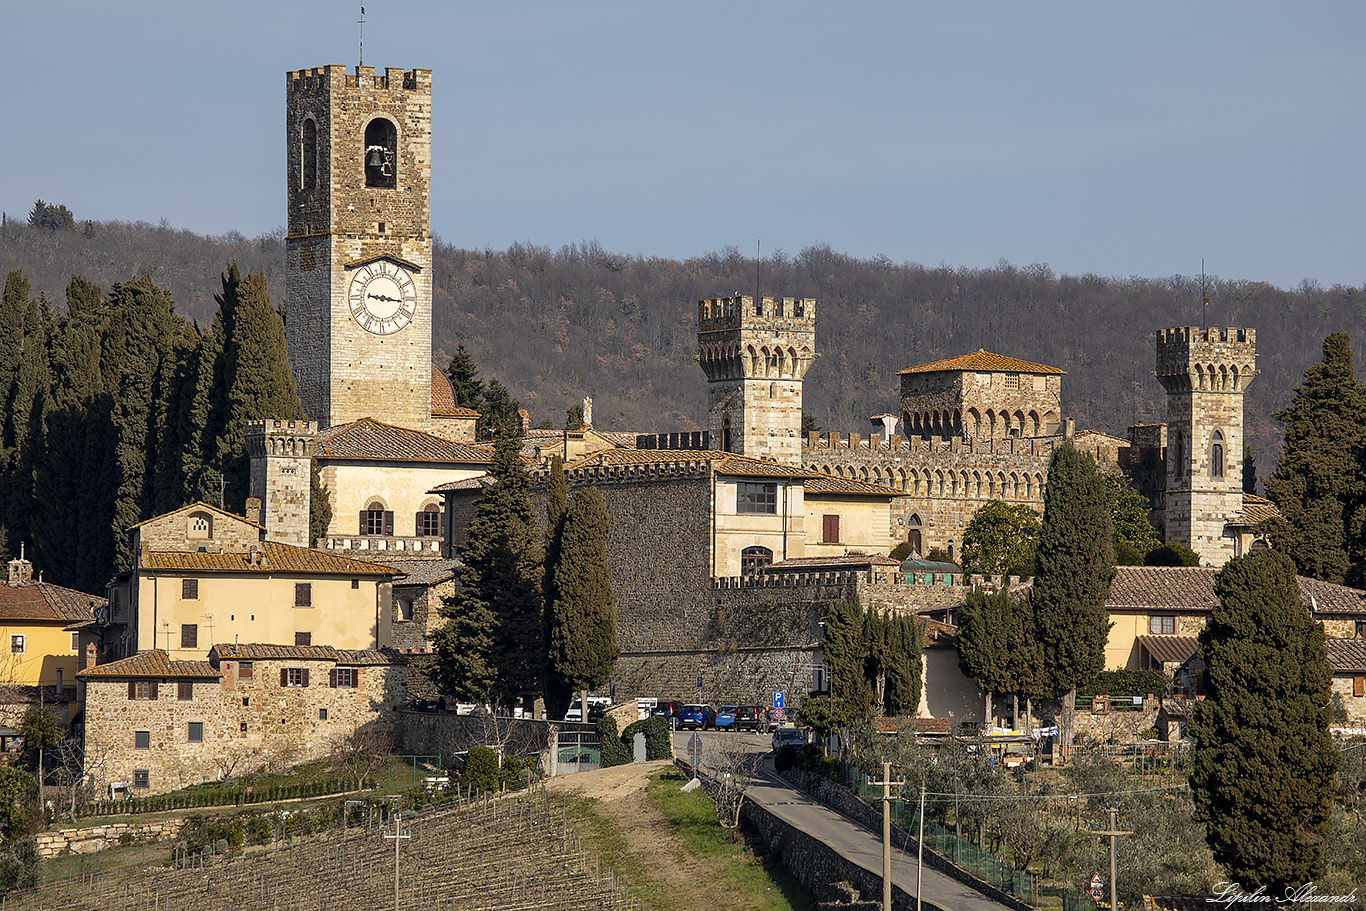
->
xmin=0 ymin=219 xmax=1366 ymax=488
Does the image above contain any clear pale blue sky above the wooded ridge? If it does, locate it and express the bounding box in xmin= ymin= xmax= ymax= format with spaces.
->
xmin=0 ymin=0 xmax=1366 ymax=287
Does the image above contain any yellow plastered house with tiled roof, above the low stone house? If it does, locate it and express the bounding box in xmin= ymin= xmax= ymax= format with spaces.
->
xmin=104 ymin=503 xmax=402 ymax=660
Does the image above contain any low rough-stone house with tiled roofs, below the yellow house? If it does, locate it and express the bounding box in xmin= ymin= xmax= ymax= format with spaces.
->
xmin=78 ymin=643 xmax=407 ymax=795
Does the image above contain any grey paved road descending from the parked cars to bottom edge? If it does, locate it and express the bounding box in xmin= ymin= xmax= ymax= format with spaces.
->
xmin=673 ymin=731 xmax=1007 ymax=911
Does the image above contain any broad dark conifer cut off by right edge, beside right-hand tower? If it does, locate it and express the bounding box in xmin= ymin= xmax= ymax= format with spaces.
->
xmin=1266 ymin=332 xmax=1366 ymax=582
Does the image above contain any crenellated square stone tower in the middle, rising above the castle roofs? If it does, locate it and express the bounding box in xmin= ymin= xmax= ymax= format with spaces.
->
xmin=697 ymin=296 xmax=817 ymax=466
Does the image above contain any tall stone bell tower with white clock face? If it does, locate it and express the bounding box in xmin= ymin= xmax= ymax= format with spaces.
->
xmin=285 ymin=66 xmax=432 ymax=430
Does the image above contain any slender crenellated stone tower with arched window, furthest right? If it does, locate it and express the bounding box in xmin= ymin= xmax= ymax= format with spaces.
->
xmin=1156 ymin=326 xmax=1257 ymax=567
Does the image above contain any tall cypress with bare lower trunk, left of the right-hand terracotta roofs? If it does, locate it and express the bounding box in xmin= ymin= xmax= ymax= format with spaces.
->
xmin=1030 ymin=443 xmax=1115 ymax=747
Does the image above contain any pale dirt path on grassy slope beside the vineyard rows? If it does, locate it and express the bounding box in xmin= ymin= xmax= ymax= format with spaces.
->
xmin=546 ymin=759 xmax=749 ymax=911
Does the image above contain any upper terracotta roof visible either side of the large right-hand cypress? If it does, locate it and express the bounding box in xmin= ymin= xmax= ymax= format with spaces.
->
xmin=1105 ymin=567 xmax=1366 ymax=616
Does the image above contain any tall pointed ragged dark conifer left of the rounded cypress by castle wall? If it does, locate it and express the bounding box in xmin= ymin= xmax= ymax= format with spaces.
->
xmin=432 ymin=425 xmax=544 ymax=705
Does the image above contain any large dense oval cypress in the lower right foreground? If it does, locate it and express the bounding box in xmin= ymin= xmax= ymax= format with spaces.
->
xmin=1190 ymin=550 xmax=1340 ymax=896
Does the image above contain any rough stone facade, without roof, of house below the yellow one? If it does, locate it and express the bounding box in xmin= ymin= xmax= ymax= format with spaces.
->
xmin=85 ymin=658 xmax=407 ymax=796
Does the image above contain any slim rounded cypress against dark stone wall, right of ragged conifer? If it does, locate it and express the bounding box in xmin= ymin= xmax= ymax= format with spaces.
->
xmin=549 ymin=488 xmax=617 ymax=705
